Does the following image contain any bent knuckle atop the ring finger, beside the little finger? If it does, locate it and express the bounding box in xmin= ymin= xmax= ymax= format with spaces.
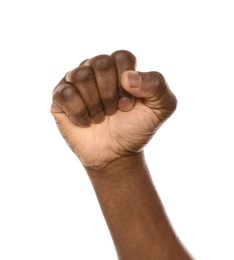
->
xmin=65 ymin=66 xmax=94 ymax=84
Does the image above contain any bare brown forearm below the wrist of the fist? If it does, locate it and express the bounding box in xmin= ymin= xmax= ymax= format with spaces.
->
xmin=86 ymin=153 xmax=191 ymax=260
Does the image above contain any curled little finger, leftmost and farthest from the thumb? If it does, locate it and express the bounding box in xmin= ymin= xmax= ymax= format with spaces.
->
xmin=52 ymin=80 xmax=90 ymax=127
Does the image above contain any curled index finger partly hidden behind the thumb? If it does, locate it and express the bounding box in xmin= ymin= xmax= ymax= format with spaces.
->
xmin=111 ymin=50 xmax=136 ymax=111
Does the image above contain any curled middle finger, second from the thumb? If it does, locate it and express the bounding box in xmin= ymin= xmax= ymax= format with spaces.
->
xmin=85 ymin=55 xmax=119 ymax=115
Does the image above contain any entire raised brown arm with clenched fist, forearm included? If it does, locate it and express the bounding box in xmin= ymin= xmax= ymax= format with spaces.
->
xmin=51 ymin=50 xmax=192 ymax=260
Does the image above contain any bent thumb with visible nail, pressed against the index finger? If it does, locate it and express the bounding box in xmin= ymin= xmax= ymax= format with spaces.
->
xmin=121 ymin=70 xmax=177 ymax=121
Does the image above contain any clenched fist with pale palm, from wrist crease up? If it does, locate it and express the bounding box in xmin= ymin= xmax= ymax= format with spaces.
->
xmin=51 ymin=50 xmax=177 ymax=168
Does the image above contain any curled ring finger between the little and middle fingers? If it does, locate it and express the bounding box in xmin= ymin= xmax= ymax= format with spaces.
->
xmin=65 ymin=66 xmax=105 ymax=124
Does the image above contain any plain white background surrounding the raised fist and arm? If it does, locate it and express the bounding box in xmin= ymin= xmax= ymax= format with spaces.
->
xmin=0 ymin=0 xmax=234 ymax=260
